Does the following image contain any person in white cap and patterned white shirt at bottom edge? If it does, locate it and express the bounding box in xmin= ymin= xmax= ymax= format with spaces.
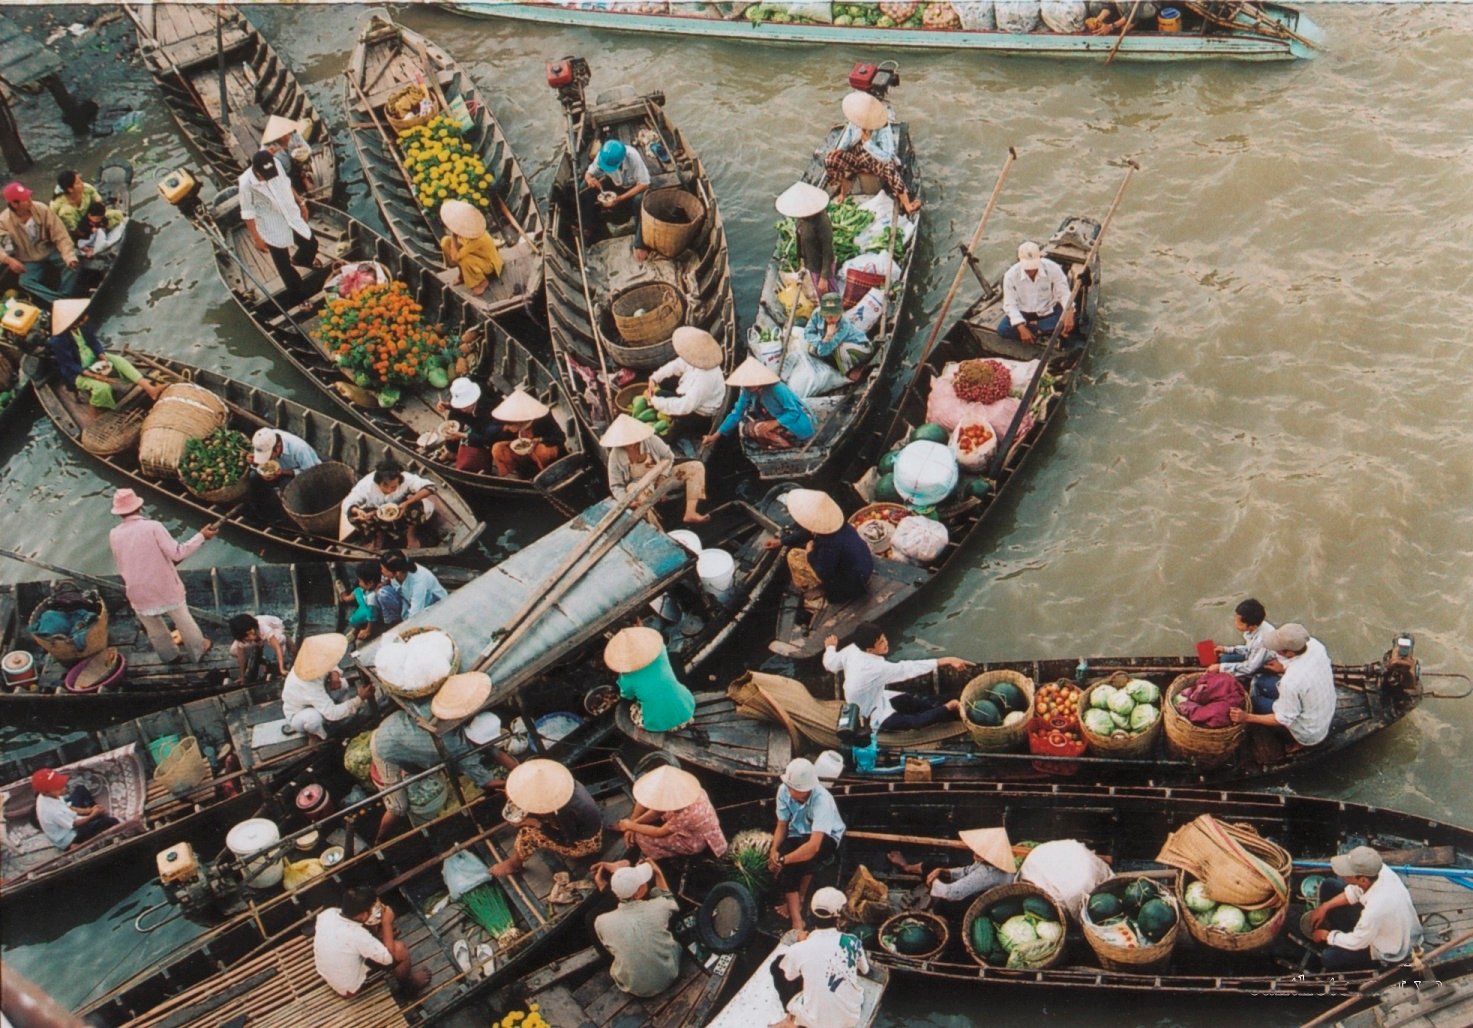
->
xmin=772 ymin=887 xmax=869 ymax=1028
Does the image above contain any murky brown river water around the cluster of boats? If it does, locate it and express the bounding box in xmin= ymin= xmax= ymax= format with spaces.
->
xmin=0 ymin=4 xmax=1473 ymax=1028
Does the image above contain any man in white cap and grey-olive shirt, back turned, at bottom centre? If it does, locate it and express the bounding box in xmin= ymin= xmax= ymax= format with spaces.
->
xmin=594 ymin=860 xmax=681 ymax=996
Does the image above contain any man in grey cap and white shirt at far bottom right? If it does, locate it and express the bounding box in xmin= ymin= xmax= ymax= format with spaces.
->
xmin=1308 ymin=845 xmax=1421 ymax=972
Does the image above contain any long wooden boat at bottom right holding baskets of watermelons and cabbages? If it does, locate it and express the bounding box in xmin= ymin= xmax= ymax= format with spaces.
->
xmin=695 ymin=782 xmax=1473 ymax=999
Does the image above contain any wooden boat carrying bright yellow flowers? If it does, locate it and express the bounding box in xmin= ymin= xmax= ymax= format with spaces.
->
xmin=343 ymin=15 xmax=542 ymax=317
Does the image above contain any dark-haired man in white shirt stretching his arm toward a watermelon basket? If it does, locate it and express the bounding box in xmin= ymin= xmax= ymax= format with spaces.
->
xmin=823 ymin=622 xmax=966 ymax=732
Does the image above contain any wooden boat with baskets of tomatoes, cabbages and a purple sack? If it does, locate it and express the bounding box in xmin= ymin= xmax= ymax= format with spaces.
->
xmin=617 ymin=642 xmax=1467 ymax=786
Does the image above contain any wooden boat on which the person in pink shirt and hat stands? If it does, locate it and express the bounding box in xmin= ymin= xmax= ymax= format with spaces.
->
xmin=0 ymin=564 xmax=338 ymax=725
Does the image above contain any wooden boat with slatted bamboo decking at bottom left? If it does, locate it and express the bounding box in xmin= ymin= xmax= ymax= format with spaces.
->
xmin=82 ymin=761 xmax=632 ymax=1028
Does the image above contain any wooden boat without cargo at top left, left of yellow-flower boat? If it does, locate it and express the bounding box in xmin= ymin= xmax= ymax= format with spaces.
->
xmin=122 ymin=3 xmax=337 ymax=200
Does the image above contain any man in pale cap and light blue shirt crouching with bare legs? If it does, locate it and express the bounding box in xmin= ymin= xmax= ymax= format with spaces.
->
xmin=767 ymin=757 xmax=844 ymax=931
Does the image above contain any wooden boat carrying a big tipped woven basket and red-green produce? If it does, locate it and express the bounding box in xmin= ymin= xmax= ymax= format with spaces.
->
xmin=35 ymin=352 xmax=486 ymax=561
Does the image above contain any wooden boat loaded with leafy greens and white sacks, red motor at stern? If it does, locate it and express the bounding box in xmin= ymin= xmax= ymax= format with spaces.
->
xmin=741 ymin=97 xmax=925 ymax=482
